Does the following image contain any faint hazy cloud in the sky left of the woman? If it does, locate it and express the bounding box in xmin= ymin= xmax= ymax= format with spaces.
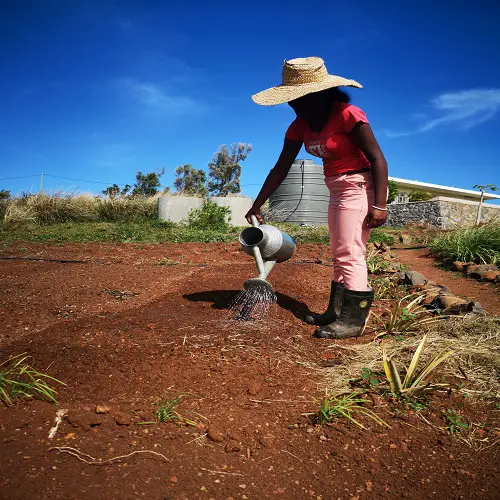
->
xmin=123 ymin=79 xmax=206 ymax=115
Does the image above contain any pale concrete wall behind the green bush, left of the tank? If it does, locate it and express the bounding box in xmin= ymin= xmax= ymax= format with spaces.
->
xmin=158 ymin=196 xmax=253 ymax=226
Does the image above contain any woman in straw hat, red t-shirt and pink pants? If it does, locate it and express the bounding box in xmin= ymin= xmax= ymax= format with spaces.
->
xmin=246 ymin=57 xmax=387 ymax=339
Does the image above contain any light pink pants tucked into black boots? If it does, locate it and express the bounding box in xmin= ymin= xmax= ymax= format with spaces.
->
xmin=325 ymin=172 xmax=374 ymax=292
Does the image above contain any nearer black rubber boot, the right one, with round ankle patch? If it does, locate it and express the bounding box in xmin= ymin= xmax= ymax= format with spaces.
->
xmin=313 ymin=289 xmax=373 ymax=339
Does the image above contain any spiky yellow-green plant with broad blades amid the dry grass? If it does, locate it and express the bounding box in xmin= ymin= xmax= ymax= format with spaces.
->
xmin=382 ymin=335 xmax=453 ymax=397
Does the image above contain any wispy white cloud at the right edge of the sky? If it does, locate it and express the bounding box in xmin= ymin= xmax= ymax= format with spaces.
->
xmin=385 ymin=88 xmax=500 ymax=137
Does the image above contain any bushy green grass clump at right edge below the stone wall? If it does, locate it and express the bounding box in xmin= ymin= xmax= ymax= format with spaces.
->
xmin=430 ymin=219 xmax=500 ymax=265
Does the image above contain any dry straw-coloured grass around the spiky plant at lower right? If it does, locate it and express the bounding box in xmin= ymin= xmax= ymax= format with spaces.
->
xmin=327 ymin=316 xmax=500 ymax=397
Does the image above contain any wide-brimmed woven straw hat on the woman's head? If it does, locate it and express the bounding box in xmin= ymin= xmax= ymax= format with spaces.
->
xmin=252 ymin=57 xmax=362 ymax=106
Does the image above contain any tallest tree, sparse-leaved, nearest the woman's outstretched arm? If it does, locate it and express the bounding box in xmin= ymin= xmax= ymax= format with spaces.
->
xmin=208 ymin=142 xmax=252 ymax=196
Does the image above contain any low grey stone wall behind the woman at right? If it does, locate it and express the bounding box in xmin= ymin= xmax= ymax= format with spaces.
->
xmin=387 ymin=196 xmax=500 ymax=229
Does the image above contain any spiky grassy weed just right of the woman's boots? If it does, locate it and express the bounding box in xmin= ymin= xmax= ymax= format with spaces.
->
xmin=373 ymin=294 xmax=445 ymax=337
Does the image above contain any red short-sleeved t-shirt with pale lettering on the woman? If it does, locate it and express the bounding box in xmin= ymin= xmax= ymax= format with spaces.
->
xmin=286 ymin=102 xmax=370 ymax=177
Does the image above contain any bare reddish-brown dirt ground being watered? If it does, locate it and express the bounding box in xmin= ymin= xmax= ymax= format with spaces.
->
xmin=0 ymin=243 xmax=500 ymax=500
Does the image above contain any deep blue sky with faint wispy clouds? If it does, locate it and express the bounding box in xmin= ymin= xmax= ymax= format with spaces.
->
xmin=0 ymin=0 xmax=500 ymax=196
